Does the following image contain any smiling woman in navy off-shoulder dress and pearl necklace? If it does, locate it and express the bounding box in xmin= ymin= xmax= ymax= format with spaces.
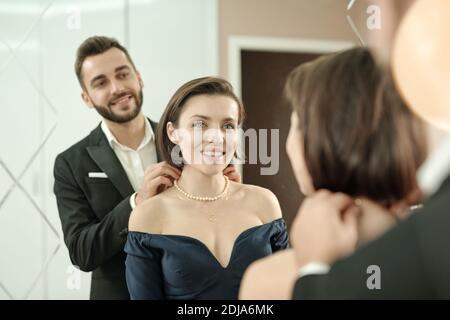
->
xmin=125 ymin=77 xmax=288 ymax=299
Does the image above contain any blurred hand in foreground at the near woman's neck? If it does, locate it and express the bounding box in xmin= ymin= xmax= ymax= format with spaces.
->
xmin=291 ymin=190 xmax=360 ymax=268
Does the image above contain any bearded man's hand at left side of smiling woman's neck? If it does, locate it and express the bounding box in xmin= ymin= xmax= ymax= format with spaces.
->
xmin=135 ymin=161 xmax=181 ymax=205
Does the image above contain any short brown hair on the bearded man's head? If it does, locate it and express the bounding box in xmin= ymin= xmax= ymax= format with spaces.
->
xmin=75 ymin=36 xmax=136 ymax=89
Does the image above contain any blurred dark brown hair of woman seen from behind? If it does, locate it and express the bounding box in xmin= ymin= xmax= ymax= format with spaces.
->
xmin=285 ymin=48 xmax=427 ymax=205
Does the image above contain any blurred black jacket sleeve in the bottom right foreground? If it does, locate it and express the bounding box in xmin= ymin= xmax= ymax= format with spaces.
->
xmin=293 ymin=177 xmax=450 ymax=299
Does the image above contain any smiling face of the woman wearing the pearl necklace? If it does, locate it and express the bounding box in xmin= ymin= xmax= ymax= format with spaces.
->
xmin=167 ymin=94 xmax=239 ymax=175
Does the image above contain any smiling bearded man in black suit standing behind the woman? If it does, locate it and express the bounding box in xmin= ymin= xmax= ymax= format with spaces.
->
xmin=54 ymin=36 xmax=239 ymax=299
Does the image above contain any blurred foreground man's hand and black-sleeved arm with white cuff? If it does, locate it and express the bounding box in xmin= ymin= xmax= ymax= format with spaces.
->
xmin=291 ymin=184 xmax=450 ymax=299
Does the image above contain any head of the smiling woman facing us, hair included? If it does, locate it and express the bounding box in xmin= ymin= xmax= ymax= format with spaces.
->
xmin=157 ymin=77 xmax=244 ymax=178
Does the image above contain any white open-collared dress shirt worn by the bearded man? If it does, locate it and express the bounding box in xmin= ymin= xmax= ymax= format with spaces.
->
xmin=101 ymin=119 xmax=158 ymax=209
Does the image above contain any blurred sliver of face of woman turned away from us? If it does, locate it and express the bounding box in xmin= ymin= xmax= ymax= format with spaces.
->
xmin=286 ymin=112 xmax=314 ymax=196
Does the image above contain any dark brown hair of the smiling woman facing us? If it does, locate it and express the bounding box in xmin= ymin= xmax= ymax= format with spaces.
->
xmin=156 ymin=77 xmax=245 ymax=167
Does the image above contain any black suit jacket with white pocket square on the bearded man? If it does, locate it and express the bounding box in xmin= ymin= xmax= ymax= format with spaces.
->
xmin=54 ymin=120 xmax=159 ymax=299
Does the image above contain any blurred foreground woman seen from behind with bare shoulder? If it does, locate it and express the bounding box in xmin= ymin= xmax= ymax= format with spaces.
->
xmin=240 ymin=48 xmax=426 ymax=299
